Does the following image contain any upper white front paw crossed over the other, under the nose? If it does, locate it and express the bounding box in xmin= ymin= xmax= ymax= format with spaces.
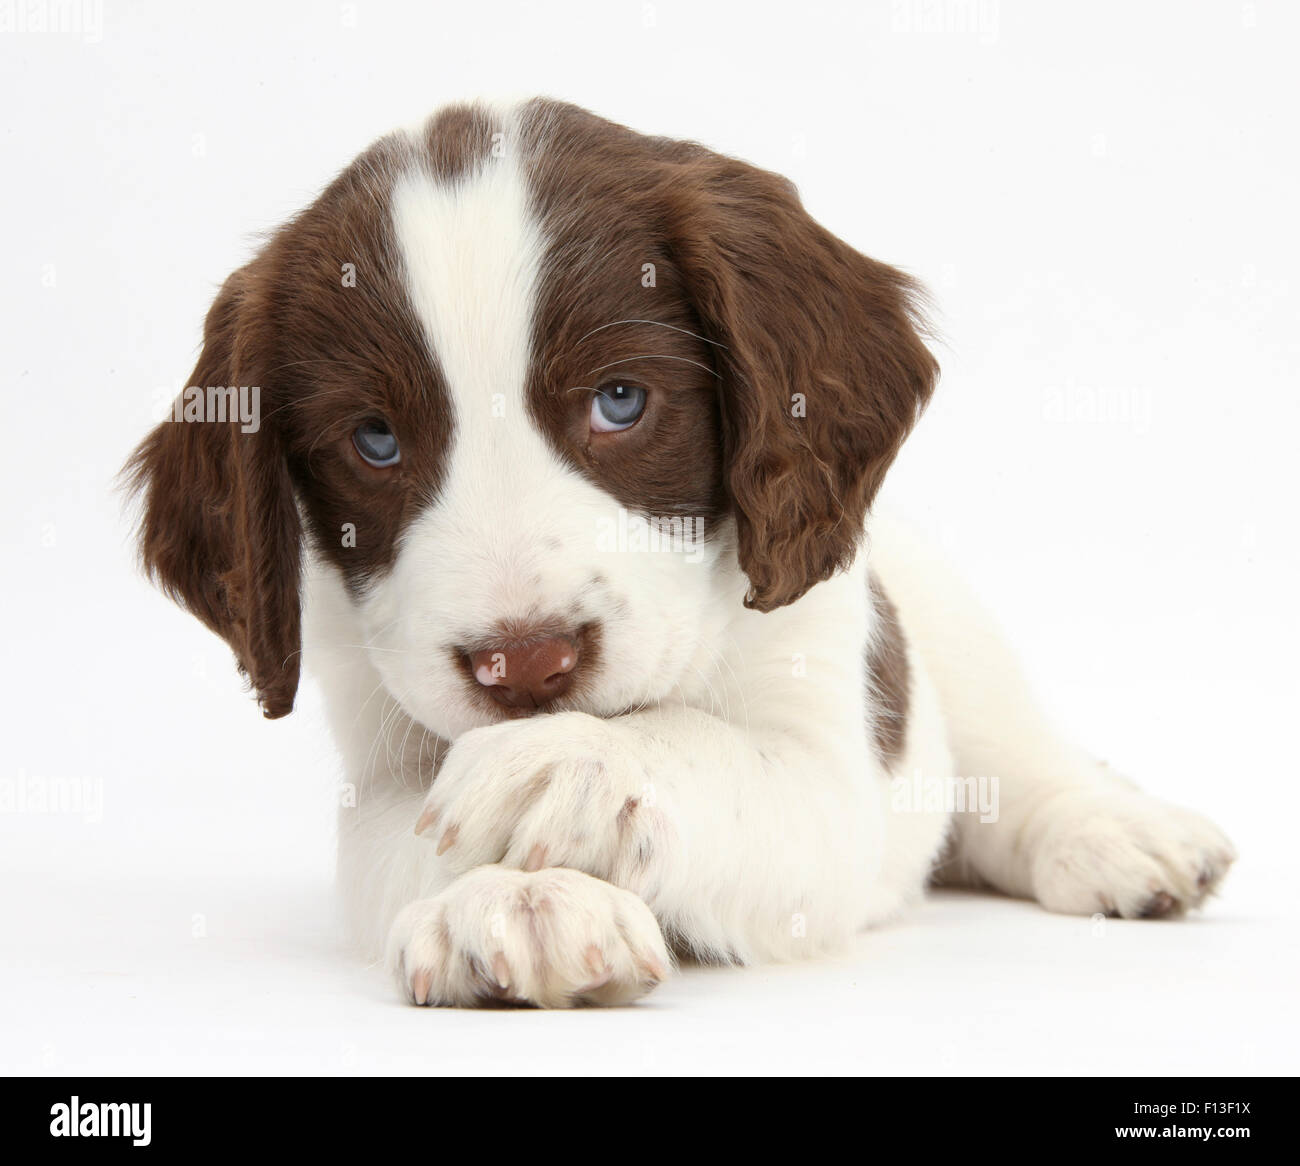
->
xmin=416 ymin=712 xmax=673 ymax=892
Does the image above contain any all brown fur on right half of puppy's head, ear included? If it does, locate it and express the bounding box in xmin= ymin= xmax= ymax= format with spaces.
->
xmin=512 ymin=101 xmax=937 ymax=611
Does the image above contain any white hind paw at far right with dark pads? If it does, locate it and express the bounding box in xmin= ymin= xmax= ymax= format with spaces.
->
xmin=1032 ymin=792 xmax=1236 ymax=919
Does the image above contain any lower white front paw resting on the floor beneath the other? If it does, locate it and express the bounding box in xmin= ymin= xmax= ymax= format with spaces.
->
xmin=387 ymin=867 xmax=670 ymax=1007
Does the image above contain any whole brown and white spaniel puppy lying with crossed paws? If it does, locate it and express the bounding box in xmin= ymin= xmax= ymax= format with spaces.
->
xmin=130 ymin=100 xmax=1235 ymax=1007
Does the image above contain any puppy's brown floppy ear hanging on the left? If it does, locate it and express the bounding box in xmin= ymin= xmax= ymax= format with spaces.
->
xmin=124 ymin=263 xmax=302 ymax=718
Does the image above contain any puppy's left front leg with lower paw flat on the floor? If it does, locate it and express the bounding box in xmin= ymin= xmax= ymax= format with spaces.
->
xmin=327 ymin=722 xmax=671 ymax=1007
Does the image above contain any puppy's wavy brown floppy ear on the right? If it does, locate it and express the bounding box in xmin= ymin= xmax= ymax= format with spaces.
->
xmin=668 ymin=155 xmax=939 ymax=611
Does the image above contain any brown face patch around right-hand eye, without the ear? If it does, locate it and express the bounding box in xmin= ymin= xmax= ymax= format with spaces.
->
xmin=521 ymin=101 xmax=727 ymax=534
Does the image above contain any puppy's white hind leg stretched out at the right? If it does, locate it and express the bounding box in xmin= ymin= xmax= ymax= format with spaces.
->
xmin=872 ymin=524 xmax=1236 ymax=918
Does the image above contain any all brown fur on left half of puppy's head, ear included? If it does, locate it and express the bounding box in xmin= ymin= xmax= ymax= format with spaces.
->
xmin=127 ymin=108 xmax=493 ymax=716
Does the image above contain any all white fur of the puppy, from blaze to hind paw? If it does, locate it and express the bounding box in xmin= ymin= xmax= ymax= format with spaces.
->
xmin=299 ymin=109 xmax=1231 ymax=1005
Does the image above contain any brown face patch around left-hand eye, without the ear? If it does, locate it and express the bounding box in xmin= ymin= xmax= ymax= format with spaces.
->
xmin=263 ymin=139 xmax=452 ymax=590
